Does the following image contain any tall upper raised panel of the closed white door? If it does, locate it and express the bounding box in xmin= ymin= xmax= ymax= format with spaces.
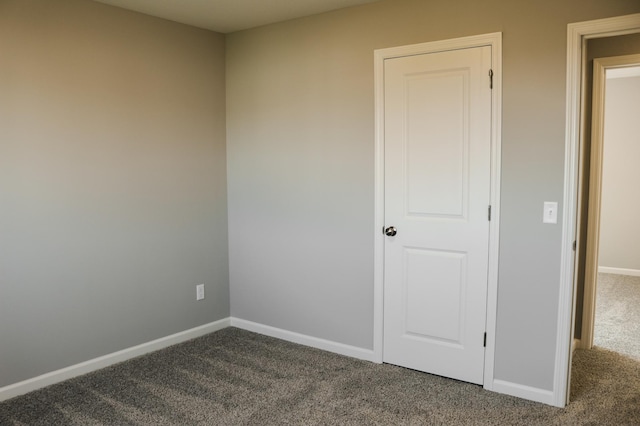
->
xmin=403 ymin=70 xmax=468 ymax=217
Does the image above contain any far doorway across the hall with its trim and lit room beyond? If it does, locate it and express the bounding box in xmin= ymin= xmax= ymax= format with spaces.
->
xmin=576 ymin=60 xmax=640 ymax=360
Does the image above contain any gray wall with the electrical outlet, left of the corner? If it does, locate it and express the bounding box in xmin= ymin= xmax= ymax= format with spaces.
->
xmin=0 ymin=0 xmax=229 ymax=386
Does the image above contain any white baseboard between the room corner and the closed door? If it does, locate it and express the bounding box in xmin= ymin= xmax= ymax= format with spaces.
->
xmin=231 ymin=317 xmax=376 ymax=362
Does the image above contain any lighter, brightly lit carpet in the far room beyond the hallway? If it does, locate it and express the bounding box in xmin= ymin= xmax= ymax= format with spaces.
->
xmin=593 ymin=274 xmax=640 ymax=360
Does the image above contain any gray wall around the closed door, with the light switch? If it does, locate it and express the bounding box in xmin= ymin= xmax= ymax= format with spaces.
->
xmin=227 ymin=0 xmax=640 ymax=390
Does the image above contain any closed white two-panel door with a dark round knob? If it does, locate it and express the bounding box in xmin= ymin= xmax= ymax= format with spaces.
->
xmin=383 ymin=46 xmax=491 ymax=384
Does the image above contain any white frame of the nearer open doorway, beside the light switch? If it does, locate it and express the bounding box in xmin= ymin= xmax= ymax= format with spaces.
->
xmin=553 ymin=13 xmax=640 ymax=407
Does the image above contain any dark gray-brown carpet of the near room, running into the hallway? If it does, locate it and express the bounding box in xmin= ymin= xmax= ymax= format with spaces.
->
xmin=0 ymin=328 xmax=640 ymax=425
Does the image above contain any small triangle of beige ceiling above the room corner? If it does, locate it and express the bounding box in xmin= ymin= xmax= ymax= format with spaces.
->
xmin=95 ymin=0 xmax=377 ymax=33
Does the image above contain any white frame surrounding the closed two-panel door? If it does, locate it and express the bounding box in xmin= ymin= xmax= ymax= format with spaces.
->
xmin=373 ymin=33 xmax=502 ymax=390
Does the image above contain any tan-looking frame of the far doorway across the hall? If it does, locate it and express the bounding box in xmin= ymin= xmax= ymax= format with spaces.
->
xmin=579 ymin=54 xmax=640 ymax=349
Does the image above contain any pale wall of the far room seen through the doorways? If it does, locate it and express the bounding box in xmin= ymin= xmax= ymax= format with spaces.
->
xmin=598 ymin=77 xmax=640 ymax=270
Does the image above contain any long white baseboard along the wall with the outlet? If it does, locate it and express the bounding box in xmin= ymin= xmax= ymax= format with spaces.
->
xmin=0 ymin=318 xmax=230 ymax=401
